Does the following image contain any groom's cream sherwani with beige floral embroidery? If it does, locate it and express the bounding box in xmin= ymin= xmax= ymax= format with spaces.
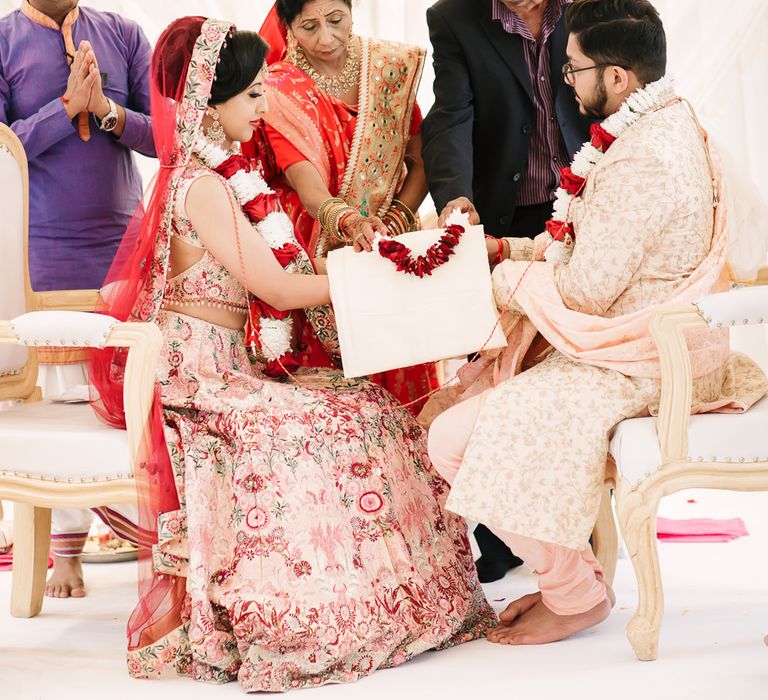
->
xmin=447 ymin=103 xmax=766 ymax=549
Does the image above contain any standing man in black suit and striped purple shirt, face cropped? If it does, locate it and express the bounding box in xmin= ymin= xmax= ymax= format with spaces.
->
xmin=422 ymin=0 xmax=589 ymax=583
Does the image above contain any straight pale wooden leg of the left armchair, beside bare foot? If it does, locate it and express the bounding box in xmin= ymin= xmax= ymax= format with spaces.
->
xmin=11 ymin=503 xmax=51 ymax=617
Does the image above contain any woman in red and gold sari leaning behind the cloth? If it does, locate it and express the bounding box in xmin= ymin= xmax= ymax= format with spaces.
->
xmin=246 ymin=0 xmax=437 ymax=413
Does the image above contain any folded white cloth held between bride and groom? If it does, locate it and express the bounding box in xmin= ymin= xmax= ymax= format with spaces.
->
xmin=328 ymin=221 xmax=506 ymax=377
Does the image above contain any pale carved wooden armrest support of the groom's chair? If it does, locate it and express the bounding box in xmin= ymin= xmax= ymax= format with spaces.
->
xmin=649 ymin=305 xmax=707 ymax=465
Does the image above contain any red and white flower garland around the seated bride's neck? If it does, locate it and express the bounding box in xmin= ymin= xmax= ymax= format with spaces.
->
xmin=194 ymin=136 xmax=301 ymax=376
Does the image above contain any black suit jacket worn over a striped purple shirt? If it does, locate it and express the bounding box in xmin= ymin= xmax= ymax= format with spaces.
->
xmin=422 ymin=0 xmax=590 ymax=236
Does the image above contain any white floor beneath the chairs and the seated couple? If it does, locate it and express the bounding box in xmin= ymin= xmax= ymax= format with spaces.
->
xmin=0 ymin=491 xmax=768 ymax=700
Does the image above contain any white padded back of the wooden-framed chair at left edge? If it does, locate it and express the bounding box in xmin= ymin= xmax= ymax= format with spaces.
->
xmin=0 ymin=124 xmax=30 ymax=377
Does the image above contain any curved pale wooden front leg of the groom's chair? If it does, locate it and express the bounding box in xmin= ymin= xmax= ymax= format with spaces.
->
xmin=616 ymin=494 xmax=664 ymax=661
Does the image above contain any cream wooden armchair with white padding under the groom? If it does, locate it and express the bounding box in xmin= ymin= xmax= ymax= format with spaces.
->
xmin=594 ymin=282 xmax=768 ymax=661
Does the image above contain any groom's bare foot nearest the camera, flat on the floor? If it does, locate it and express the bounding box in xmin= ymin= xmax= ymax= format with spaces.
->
xmin=488 ymin=598 xmax=611 ymax=645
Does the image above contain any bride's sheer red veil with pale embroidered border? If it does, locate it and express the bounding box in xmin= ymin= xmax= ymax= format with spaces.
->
xmin=89 ymin=17 xmax=234 ymax=650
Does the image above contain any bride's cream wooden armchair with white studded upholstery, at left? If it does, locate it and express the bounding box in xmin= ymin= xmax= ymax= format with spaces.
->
xmin=0 ymin=124 xmax=162 ymax=617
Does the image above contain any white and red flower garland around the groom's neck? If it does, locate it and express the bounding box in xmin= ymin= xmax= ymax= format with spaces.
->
xmin=544 ymin=77 xmax=674 ymax=262
